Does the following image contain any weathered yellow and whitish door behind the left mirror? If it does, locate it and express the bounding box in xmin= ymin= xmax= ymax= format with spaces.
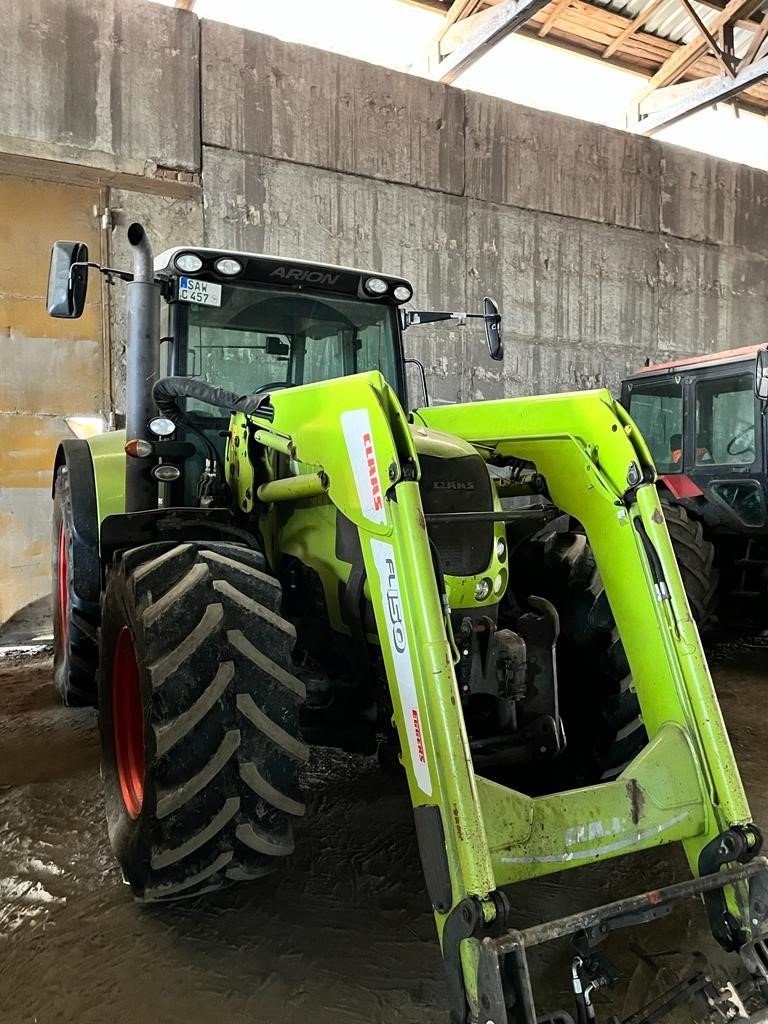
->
xmin=0 ymin=172 xmax=106 ymax=626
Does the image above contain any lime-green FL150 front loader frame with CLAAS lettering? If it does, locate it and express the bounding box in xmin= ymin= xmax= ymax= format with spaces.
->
xmin=240 ymin=373 xmax=768 ymax=1024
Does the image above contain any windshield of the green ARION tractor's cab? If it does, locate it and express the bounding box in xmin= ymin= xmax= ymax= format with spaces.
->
xmin=179 ymin=285 xmax=399 ymax=413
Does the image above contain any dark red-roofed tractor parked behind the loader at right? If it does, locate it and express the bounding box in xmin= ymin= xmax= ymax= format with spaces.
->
xmin=622 ymin=345 xmax=768 ymax=630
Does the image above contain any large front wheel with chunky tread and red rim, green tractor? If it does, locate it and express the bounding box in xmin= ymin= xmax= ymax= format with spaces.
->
xmin=99 ymin=542 xmax=308 ymax=901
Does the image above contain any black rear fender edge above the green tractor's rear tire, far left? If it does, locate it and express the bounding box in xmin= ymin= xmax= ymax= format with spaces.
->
xmin=51 ymin=438 xmax=101 ymax=604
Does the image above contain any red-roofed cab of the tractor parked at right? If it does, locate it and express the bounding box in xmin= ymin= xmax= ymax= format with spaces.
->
xmin=622 ymin=345 xmax=768 ymax=535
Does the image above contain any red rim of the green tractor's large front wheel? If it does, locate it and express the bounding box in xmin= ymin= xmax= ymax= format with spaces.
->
xmin=112 ymin=626 xmax=144 ymax=818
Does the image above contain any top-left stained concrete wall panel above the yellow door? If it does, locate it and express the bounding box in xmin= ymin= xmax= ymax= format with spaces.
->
xmin=0 ymin=0 xmax=200 ymax=175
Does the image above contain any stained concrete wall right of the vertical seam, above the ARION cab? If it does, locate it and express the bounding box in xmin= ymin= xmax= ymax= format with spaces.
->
xmin=202 ymin=22 xmax=768 ymax=400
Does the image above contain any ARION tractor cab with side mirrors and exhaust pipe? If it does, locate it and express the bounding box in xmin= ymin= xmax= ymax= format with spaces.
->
xmin=48 ymin=234 xmax=503 ymax=512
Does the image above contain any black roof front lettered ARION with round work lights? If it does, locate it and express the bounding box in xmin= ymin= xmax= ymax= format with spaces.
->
xmin=155 ymin=246 xmax=413 ymax=302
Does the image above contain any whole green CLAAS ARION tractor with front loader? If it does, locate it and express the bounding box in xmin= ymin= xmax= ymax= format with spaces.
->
xmin=48 ymin=224 xmax=768 ymax=1024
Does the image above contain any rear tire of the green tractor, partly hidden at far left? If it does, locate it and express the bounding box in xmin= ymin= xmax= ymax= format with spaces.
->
xmin=51 ymin=464 xmax=99 ymax=707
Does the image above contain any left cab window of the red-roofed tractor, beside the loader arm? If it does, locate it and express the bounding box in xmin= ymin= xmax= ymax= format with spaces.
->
xmin=630 ymin=377 xmax=683 ymax=473
